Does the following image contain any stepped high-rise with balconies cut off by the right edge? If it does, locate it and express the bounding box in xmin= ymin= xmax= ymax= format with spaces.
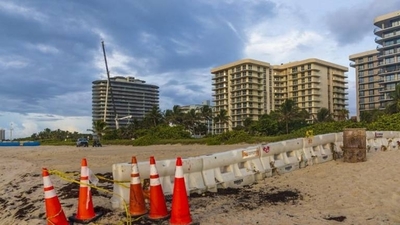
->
xmin=349 ymin=11 xmax=400 ymax=118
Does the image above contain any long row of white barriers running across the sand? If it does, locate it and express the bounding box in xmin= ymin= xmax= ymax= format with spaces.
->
xmin=111 ymin=131 xmax=400 ymax=208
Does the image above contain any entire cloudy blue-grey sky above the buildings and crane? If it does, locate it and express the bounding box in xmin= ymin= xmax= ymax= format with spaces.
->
xmin=0 ymin=0 xmax=400 ymax=138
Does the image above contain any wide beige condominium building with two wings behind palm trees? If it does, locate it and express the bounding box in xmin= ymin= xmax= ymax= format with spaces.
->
xmin=211 ymin=58 xmax=348 ymax=133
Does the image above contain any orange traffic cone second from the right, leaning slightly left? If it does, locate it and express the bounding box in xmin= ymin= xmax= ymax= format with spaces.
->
xmin=148 ymin=156 xmax=169 ymax=220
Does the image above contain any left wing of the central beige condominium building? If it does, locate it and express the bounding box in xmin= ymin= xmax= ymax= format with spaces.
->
xmin=211 ymin=59 xmax=272 ymax=134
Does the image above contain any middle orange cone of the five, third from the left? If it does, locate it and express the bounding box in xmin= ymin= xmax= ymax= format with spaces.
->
xmin=129 ymin=156 xmax=147 ymax=216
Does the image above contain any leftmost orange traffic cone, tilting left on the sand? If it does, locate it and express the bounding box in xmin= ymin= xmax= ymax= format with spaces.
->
xmin=42 ymin=168 xmax=69 ymax=225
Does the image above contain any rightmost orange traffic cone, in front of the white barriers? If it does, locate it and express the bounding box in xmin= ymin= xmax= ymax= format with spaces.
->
xmin=169 ymin=157 xmax=192 ymax=225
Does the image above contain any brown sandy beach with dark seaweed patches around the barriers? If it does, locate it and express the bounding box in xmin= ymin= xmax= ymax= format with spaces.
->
xmin=0 ymin=144 xmax=400 ymax=225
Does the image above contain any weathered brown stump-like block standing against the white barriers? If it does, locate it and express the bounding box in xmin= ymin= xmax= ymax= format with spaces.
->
xmin=343 ymin=128 xmax=367 ymax=163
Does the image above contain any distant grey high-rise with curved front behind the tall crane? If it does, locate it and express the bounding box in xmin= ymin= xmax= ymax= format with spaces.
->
xmin=92 ymin=76 xmax=159 ymax=129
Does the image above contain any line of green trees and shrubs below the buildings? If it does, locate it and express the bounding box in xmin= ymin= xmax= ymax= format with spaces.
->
xmin=31 ymin=85 xmax=400 ymax=140
